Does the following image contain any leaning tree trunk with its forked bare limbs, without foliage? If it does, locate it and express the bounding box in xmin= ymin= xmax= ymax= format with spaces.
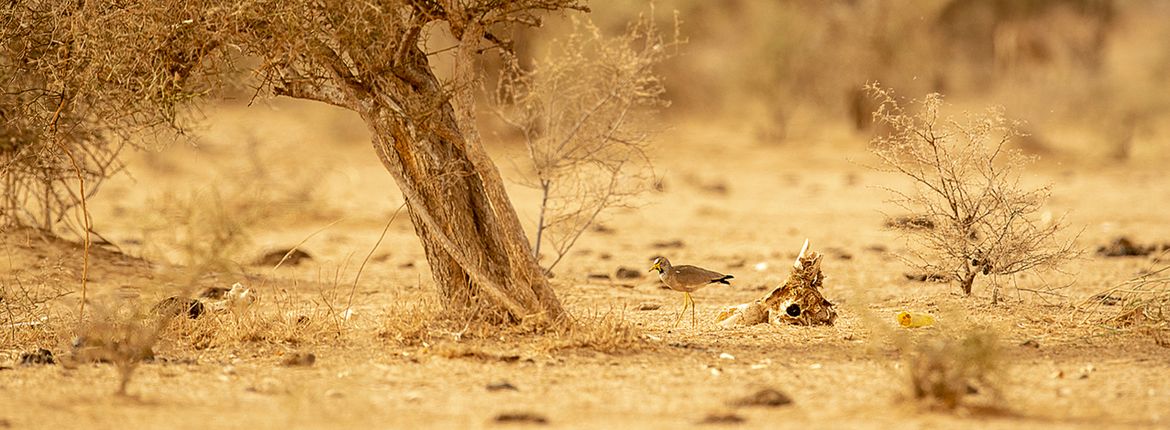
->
xmin=274 ymin=14 xmax=565 ymax=324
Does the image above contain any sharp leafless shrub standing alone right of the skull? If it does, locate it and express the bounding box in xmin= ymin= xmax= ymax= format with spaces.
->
xmin=867 ymin=84 xmax=1079 ymax=294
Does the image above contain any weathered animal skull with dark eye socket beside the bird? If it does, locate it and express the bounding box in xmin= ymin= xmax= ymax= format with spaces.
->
xmin=717 ymin=241 xmax=837 ymax=327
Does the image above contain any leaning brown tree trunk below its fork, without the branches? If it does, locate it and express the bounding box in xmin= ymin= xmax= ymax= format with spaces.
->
xmin=346 ymin=36 xmax=565 ymax=323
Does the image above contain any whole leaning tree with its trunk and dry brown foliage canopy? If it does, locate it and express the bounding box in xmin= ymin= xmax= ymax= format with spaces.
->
xmin=0 ymin=0 xmax=587 ymax=321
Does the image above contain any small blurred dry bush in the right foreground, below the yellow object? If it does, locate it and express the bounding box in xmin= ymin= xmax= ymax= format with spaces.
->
xmin=907 ymin=328 xmax=1002 ymax=410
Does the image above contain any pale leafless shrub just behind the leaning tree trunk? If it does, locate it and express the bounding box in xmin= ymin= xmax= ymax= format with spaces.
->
xmin=495 ymin=15 xmax=679 ymax=272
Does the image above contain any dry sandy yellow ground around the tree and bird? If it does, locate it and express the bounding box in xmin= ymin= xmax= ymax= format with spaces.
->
xmin=0 ymin=103 xmax=1170 ymax=429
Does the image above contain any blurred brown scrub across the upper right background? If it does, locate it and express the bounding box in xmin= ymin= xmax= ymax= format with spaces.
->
xmin=515 ymin=0 xmax=1170 ymax=161
